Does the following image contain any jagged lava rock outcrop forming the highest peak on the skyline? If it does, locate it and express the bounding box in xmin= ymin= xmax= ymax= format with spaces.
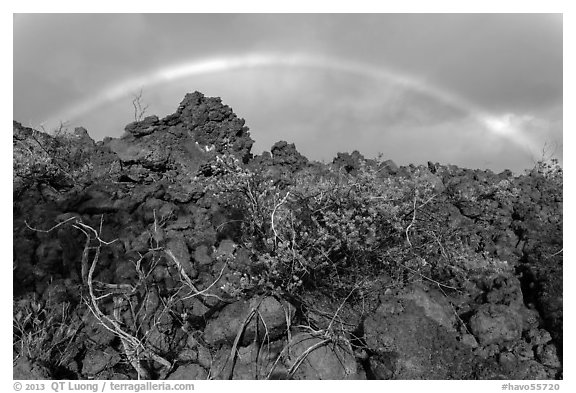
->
xmin=104 ymin=92 xmax=254 ymax=181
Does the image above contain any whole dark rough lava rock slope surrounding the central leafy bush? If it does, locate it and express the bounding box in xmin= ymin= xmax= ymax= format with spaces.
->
xmin=13 ymin=92 xmax=563 ymax=379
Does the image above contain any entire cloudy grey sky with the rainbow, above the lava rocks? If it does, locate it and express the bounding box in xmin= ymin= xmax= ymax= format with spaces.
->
xmin=13 ymin=14 xmax=563 ymax=171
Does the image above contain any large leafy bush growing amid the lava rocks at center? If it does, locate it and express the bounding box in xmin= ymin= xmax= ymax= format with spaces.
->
xmin=198 ymin=156 xmax=452 ymax=293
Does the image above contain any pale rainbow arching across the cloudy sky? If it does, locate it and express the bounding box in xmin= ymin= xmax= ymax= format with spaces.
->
xmin=44 ymin=53 xmax=537 ymax=151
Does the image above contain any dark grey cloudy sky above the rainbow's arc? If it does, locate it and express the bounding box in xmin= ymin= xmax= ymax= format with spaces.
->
xmin=14 ymin=14 xmax=562 ymax=115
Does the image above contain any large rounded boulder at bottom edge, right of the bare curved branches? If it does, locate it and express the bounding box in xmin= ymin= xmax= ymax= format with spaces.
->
xmin=364 ymin=289 xmax=472 ymax=379
